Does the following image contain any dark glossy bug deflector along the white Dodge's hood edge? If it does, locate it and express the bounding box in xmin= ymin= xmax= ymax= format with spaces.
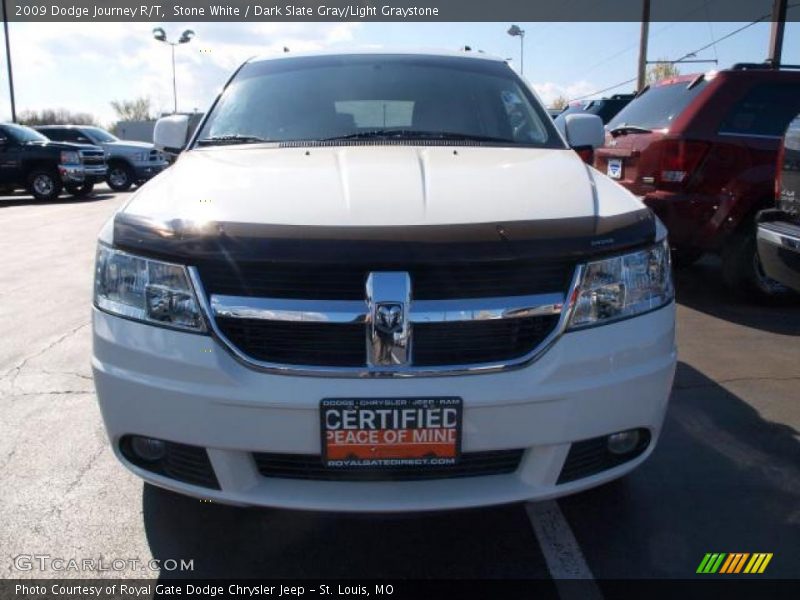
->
xmin=109 ymin=209 xmax=656 ymax=264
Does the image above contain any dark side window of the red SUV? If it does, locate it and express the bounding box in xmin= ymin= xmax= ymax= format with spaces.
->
xmin=719 ymin=82 xmax=800 ymax=137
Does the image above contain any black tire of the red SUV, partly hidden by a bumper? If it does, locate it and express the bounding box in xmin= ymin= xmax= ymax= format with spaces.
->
xmin=722 ymin=226 xmax=792 ymax=303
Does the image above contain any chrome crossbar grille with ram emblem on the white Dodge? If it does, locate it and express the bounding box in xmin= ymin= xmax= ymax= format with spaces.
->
xmin=189 ymin=267 xmax=582 ymax=376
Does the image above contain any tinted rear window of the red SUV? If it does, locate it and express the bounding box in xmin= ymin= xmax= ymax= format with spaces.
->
xmin=607 ymin=80 xmax=708 ymax=131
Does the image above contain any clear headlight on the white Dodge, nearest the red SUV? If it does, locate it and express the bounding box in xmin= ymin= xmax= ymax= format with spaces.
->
xmin=569 ymin=240 xmax=674 ymax=328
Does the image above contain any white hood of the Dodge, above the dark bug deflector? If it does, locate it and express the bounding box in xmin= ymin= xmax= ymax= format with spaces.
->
xmin=125 ymin=146 xmax=642 ymax=227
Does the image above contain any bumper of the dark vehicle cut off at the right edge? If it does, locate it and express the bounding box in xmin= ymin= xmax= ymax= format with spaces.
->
xmin=756 ymin=210 xmax=800 ymax=292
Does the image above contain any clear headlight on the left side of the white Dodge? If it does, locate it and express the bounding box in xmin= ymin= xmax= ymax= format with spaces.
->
xmin=94 ymin=244 xmax=205 ymax=331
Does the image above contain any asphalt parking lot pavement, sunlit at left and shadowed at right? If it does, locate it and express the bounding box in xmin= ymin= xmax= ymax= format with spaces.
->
xmin=0 ymin=187 xmax=800 ymax=578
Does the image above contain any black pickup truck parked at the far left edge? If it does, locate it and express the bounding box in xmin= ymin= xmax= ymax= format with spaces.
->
xmin=0 ymin=123 xmax=107 ymax=200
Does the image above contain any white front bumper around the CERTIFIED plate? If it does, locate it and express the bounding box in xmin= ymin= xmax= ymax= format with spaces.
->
xmin=92 ymin=304 xmax=676 ymax=511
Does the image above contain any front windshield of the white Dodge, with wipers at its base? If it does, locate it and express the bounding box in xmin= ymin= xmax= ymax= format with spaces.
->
xmin=197 ymin=55 xmax=563 ymax=148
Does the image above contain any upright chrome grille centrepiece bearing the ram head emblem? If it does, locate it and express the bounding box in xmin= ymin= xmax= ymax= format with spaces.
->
xmin=366 ymin=271 xmax=411 ymax=368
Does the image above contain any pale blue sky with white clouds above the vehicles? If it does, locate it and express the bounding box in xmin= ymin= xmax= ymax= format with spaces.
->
xmin=0 ymin=16 xmax=800 ymax=125
